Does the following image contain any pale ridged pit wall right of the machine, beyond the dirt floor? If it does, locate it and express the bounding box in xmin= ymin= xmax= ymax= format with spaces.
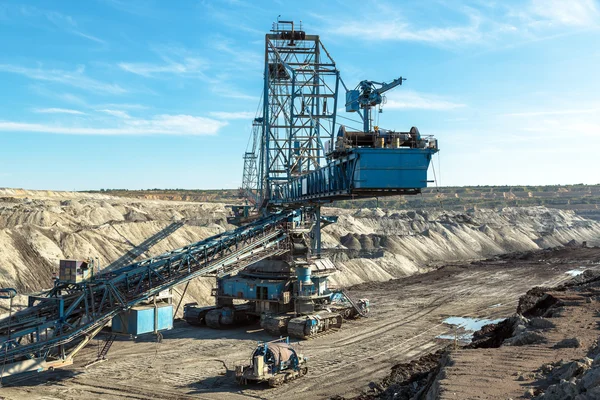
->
xmin=323 ymin=207 xmax=600 ymax=286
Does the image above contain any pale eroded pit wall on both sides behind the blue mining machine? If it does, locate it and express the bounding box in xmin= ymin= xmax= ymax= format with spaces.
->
xmin=0 ymin=189 xmax=600 ymax=314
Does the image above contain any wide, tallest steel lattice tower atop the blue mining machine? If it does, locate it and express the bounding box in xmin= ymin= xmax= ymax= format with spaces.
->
xmin=258 ymin=21 xmax=340 ymax=204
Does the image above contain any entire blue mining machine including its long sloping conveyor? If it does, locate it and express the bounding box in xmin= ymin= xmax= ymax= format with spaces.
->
xmin=0 ymin=21 xmax=438 ymax=377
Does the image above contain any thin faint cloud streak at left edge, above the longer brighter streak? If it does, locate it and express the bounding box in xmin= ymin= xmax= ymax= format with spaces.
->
xmin=0 ymin=64 xmax=127 ymax=94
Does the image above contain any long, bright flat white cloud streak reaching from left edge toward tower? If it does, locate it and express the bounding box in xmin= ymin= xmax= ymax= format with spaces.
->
xmin=0 ymin=114 xmax=227 ymax=136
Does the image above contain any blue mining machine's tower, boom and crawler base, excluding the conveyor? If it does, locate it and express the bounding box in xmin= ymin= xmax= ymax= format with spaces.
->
xmin=184 ymin=21 xmax=438 ymax=339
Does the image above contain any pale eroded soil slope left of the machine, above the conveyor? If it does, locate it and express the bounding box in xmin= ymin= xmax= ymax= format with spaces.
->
xmin=0 ymin=189 xmax=228 ymax=310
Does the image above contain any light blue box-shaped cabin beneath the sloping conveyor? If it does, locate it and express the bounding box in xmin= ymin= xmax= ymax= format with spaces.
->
xmin=112 ymin=304 xmax=173 ymax=336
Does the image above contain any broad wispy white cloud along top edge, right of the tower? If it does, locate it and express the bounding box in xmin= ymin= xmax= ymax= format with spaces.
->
xmin=322 ymin=0 xmax=600 ymax=46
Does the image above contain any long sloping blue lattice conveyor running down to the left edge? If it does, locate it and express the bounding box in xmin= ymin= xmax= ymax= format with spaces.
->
xmin=0 ymin=211 xmax=294 ymax=375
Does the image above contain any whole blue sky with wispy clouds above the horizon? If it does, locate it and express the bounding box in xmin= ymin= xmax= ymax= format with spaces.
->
xmin=0 ymin=0 xmax=600 ymax=190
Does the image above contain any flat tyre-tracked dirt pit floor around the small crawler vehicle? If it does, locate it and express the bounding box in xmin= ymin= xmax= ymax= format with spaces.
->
xmin=2 ymin=248 xmax=600 ymax=399
